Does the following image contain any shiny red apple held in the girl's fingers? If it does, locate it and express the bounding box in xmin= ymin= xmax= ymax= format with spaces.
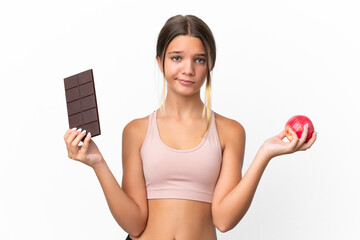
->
xmin=285 ymin=115 xmax=314 ymax=142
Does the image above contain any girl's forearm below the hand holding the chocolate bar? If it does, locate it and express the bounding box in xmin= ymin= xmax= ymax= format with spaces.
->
xmin=93 ymin=161 xmax=146 ymax=236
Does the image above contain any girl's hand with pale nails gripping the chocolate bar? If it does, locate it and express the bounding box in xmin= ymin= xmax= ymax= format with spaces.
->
xmin=64 ymin=129 xmax=104 ymax=167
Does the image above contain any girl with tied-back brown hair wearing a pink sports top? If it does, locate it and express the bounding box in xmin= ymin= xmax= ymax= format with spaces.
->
xmin=64 ymin=15 xmax=316 ymax=240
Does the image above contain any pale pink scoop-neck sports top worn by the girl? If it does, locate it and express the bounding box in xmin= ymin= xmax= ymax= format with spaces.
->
xmin=140 ymin=111 xmax=222 ymax=203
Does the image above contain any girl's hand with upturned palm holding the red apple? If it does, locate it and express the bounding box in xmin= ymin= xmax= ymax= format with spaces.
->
xmin=262 ymin=126 xmax=316 ymax=159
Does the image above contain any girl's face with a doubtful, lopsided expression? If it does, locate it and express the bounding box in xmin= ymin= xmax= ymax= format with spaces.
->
xmin=157 ymin=36 xmax=207 ymax=95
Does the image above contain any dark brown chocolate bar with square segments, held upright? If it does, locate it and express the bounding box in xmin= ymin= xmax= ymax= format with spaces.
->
xmin=64 ymin=69 xmax=101 ymax=137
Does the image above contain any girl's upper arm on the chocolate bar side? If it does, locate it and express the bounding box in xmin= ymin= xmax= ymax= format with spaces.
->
xmin=122 ymin=119 xmax=148 ymax=219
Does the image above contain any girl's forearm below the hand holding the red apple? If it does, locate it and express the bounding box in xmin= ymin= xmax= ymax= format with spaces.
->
xmin=217 ymin=148 xmax=270 ymax=232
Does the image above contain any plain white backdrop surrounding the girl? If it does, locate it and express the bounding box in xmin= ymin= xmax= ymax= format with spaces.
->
xmin=0 ymin=0 xmax=360 ymax=240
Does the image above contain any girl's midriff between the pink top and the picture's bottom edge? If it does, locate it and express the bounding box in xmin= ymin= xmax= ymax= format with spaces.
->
xmin=130 ymin=199 xmax=217 ymax=240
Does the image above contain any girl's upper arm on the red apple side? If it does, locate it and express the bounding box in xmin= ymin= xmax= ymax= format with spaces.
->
xmin=212 ymin=120 xmax=245 ymax=213
